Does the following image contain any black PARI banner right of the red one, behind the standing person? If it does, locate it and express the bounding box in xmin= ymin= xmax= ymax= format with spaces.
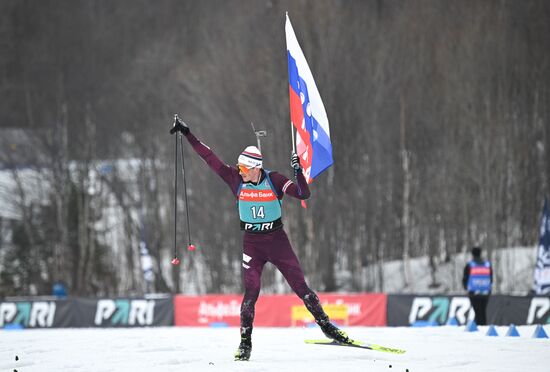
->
xmin=388 ymin=295 xmax=550 ymax=326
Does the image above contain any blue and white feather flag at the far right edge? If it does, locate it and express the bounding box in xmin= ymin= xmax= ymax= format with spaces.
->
xmin=533 ymin=199 xmax=550 ymax=294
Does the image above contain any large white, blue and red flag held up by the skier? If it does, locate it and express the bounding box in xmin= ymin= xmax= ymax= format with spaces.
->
xmin=285 ymin=14 xmax=333 ymax=182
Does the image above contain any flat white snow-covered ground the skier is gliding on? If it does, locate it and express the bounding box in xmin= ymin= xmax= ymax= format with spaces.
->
xmin=0 ymin=325 xmax=550 ymax=372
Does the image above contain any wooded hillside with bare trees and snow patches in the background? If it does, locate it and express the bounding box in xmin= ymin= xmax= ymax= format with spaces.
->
xmin=0 ymin=0 xmax=550 ymax=296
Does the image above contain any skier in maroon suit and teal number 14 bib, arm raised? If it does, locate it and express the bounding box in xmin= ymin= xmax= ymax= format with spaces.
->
xmin=171 ymin=117 xmax=350 ymax=360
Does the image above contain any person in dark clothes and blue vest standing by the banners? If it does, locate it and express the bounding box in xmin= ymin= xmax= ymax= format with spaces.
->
xmin=462 ymin=247 xmax=493 ymax=325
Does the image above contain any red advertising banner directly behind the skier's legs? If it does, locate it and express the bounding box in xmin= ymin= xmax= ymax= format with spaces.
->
xmin=174 ymin=293 xmax=386 ymax=327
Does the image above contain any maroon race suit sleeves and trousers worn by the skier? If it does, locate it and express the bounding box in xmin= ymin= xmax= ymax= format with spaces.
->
xmin=186 ymin=133 xmax=328 ymax=334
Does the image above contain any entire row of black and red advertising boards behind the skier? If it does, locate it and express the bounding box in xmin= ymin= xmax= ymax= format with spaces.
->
xmin=4 ymin=293 xmax=550 ymax=329
